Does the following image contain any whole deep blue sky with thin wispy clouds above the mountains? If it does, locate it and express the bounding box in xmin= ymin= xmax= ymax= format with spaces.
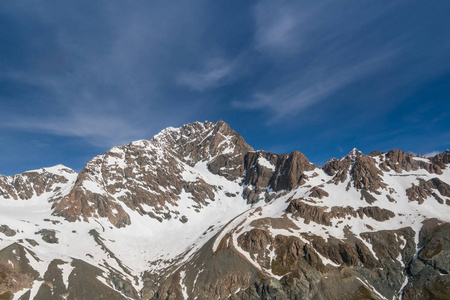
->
xmin=0 ymin=0 xmax=450 ymax=175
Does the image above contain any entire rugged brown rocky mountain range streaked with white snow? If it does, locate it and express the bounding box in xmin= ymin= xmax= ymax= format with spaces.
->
xmin=0 ymin=121 xmax=450 ymax=299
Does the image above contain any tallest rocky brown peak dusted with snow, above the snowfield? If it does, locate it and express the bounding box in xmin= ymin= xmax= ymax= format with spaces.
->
xmin=55 ymin=121 xmax=253 ymax=227
